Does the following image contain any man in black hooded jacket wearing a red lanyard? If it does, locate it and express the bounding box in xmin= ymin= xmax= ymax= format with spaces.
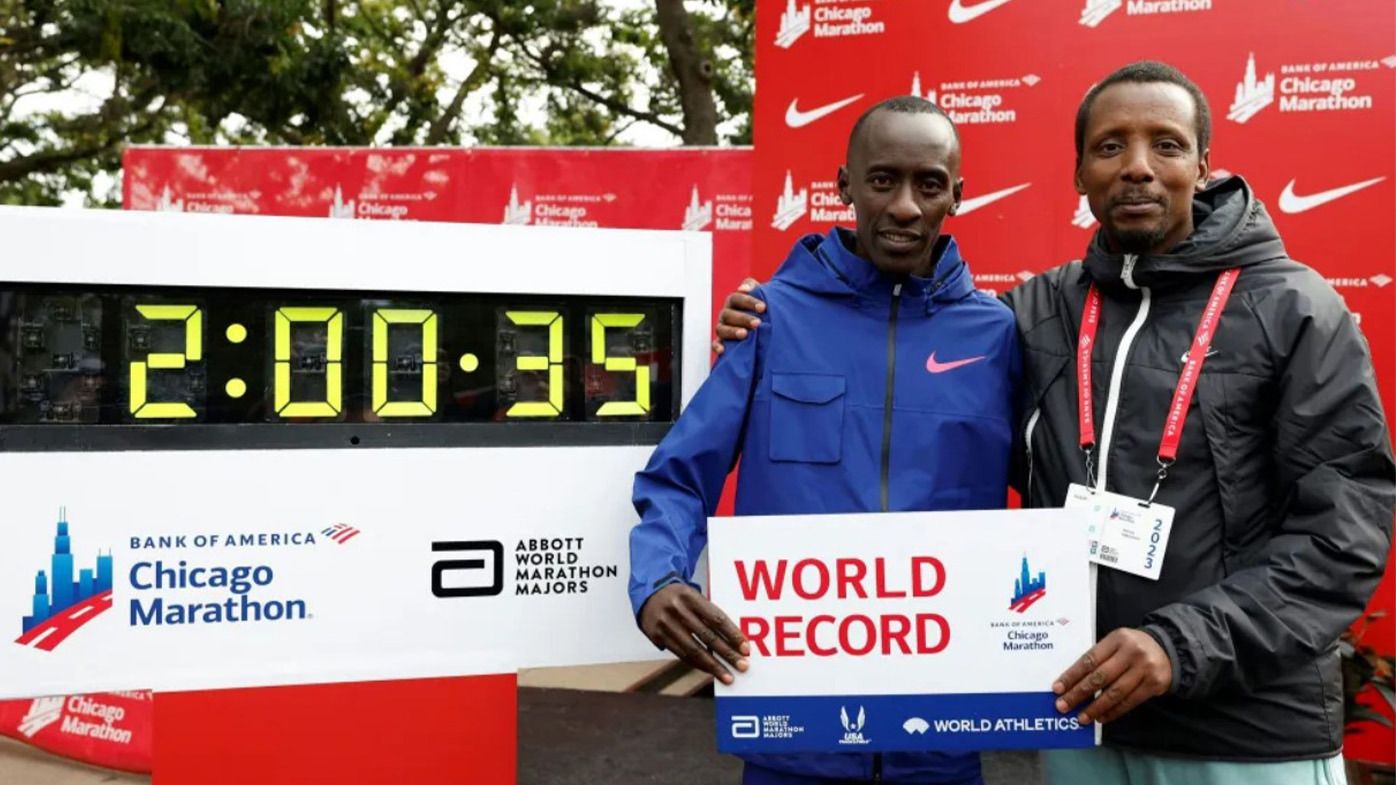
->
xmin=719 ymin=63 xmax=1396 ymax=785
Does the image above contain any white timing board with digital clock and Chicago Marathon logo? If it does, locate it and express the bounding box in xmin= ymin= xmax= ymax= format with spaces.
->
xmin=0 ymin=210 xmax=709 ymax=697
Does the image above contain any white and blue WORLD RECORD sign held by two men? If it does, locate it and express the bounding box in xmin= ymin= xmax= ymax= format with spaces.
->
xmin=709 ymin=510 xmax=1094 ymax=753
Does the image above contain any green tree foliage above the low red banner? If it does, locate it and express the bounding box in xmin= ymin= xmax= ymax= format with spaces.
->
xmin=0 ymin=0 xmax=754 ymax=204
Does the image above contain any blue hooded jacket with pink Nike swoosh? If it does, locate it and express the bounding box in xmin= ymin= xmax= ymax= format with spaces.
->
xmin=630 ymin=229 xmax=1020 ymax=782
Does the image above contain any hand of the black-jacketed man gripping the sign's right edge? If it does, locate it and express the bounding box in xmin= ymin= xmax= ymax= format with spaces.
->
xmin=1051 ymin=627 xmax=1173 ymax=725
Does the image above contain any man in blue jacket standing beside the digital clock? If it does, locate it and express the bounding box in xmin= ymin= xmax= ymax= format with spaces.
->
xmin=630 ymin=96 xmax=1019 ymax=785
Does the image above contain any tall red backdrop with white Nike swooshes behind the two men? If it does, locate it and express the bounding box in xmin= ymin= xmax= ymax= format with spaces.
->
xmin=752 ymin=0 xmax=1396 ymax=763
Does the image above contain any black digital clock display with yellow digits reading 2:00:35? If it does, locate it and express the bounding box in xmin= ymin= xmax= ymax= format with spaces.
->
xmin=0 ymin=285 xmax=681 ymax=435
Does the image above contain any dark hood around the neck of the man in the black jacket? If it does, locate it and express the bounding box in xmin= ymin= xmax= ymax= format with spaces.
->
xmin=1083 ymin=176 xmax=1287 ymax=288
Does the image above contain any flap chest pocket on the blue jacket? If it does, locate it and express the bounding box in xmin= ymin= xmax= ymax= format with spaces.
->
xmin=771 ymin=373 xmax=845 ymax=464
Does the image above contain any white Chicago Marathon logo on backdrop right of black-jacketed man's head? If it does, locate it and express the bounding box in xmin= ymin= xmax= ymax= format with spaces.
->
xmin=1226 ymin=52 xmax=1396 ymax=123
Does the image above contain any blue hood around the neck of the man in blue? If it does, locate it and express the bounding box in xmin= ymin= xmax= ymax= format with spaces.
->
xmin=776 ymin=226 xmax=974 ymax=310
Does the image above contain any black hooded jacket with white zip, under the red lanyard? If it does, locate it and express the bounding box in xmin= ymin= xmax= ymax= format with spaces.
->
xmin=1005 ymin=177 xmax=1396 ymax=761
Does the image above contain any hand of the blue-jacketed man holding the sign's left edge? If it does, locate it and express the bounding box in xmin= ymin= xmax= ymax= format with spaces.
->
xmin=639 ymin=582 xmax=751 ymax=684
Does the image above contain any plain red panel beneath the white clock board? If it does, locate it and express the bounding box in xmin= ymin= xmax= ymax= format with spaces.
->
xmin=154 ymin=673 xmax=518 ymax=785
